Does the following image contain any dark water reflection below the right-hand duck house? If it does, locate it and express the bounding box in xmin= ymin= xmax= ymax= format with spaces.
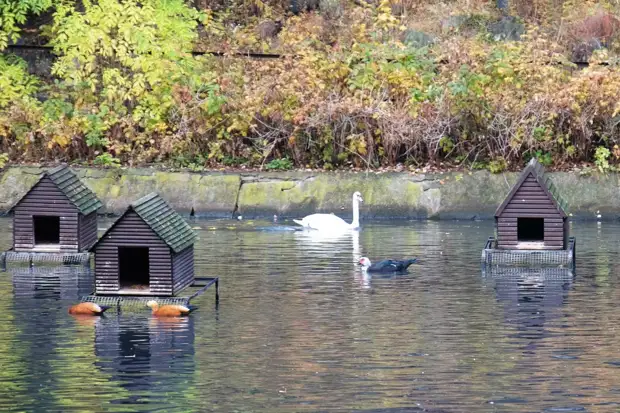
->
xmin=485 ymin=268 xmax=574 ymax=350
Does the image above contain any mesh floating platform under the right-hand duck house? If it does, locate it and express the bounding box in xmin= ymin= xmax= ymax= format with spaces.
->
xmin=480 ymin=237 xmax=576 ymax=271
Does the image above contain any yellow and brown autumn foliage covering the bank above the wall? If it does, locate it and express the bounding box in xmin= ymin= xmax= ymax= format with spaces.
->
xmin=0 ymin=0 xmax=620 ymax=172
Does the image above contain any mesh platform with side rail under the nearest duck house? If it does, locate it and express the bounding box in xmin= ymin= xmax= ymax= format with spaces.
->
xmin=82 ymin=277 xmax=220 ymax=310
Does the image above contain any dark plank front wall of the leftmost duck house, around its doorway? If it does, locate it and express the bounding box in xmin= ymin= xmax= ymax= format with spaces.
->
xmin=13 ymin=177 xmax=78 ymax=252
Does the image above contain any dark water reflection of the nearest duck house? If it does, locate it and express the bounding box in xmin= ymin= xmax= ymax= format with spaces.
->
xmin=95 ymin=313 xmax=195 ymax=404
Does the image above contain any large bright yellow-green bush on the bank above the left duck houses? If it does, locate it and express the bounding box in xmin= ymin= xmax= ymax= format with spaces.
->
xmin=51 ymin=0 xmax=211 ymax=129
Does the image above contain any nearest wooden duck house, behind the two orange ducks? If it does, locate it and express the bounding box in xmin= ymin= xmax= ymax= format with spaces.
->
xmin=91 ymin=193 xmax=196 ymax=297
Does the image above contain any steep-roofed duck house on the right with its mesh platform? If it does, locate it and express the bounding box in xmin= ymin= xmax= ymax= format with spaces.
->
xmin=483 ymin=158 xmax=575 ymax=266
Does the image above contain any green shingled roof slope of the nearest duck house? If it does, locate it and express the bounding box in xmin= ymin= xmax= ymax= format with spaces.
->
xmin=130 ymin=192 xmax=196 ymax=253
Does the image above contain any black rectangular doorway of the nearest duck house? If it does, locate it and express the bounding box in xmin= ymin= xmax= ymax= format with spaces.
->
xmin=118 ymin=247 xmax=149 ymax=293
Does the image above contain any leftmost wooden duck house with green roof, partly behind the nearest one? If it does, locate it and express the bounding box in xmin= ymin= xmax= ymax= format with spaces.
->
xmin=9 ymin=165 xmax=103 ymax=253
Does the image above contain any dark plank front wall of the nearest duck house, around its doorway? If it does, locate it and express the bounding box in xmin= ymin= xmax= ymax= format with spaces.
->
xmin=95 ymin=211 xmax=173 ymax=295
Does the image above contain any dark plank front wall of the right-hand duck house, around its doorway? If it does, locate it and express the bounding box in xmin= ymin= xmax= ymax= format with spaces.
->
xmin=497 ymin=175 xmax=568 ymax=250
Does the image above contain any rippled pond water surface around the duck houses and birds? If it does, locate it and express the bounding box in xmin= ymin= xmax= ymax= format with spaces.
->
xmin=0 ymin=219 xmax=620 ymax=412
